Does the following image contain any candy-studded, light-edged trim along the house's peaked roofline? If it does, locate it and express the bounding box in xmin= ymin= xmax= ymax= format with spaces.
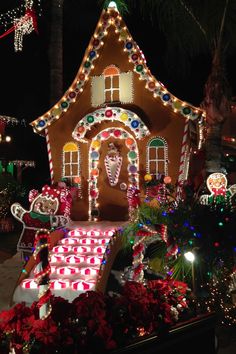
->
xmin=30 ymin=1 xmax=205 ymax=133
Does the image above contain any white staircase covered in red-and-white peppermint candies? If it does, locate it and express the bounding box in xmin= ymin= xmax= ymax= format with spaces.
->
xmin=13 ymin=226 xmax=115 ymax=304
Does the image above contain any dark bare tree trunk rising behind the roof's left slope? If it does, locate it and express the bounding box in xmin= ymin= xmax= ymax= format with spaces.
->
xmin=49 ymin=0 xmax=64 ymax=106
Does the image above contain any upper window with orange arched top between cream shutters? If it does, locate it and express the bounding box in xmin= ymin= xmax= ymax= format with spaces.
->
xmin=103 ymin=65 xmax=120 ymax=103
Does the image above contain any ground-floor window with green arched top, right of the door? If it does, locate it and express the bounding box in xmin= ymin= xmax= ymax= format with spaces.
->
xmin=147 ymin=137 xmax=168 ymax=178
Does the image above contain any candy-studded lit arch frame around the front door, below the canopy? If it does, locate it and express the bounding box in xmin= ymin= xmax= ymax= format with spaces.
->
xmin=88 ymin=127 xmax=139 ymax=221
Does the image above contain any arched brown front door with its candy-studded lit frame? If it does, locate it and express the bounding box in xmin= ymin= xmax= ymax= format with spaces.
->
xmin=88 ymin=127 xmax=139 ymax=221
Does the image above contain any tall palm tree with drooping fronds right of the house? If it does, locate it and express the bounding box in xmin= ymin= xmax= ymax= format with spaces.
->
xmin=104 ymin=0 xmax=236 ymax=174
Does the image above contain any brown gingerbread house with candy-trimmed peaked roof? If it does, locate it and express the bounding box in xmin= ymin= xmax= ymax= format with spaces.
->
xmin=31 ymin=2 xmax=204 ymax=220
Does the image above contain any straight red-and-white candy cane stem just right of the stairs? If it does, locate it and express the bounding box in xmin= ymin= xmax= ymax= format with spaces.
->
xmin=132 ymin=236 xmax=145 ymax=283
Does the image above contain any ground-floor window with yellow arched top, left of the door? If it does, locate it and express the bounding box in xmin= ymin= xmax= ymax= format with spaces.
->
xmin=62 ymin=142 xmax=80 ymax=184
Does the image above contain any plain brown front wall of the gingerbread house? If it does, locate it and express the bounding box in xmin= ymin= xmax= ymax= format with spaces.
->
xmin=48 ymin=27 xmax=185 ymax=220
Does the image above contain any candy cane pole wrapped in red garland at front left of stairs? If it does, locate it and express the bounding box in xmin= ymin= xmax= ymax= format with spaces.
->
xmin=33 ymin=229 xmax=52 ymax=320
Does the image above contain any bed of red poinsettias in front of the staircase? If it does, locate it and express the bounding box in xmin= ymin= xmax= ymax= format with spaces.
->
xmin=0 ymin=279 xmax=194 ymax=354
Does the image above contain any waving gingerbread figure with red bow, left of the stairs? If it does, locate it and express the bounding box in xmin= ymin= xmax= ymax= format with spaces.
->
xmin=11 ymin=185 xmax=72 ymax=254
